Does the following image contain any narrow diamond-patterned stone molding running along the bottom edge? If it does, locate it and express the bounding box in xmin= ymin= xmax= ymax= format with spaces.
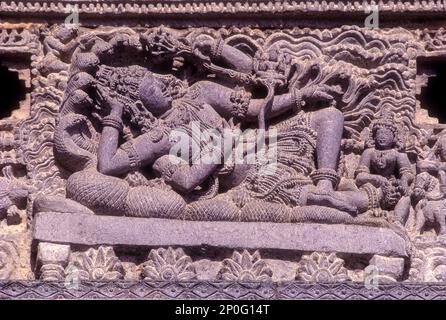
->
xmin=0 ymin=281 xmax=446 ymax=300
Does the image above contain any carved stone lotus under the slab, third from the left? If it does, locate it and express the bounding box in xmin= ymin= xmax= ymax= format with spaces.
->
xmin=218 ymin=250 xmax=273 ymax=281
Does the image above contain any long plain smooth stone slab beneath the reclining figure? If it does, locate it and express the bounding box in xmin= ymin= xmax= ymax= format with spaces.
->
xmin=34 ymin=212 xmax=408 ymax=257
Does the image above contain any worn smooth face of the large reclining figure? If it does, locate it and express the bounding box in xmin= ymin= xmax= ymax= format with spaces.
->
xmin=139 ymin=72 xmax=172 ymax=116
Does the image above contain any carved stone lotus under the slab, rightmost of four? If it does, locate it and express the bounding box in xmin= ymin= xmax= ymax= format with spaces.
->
xmin=296 ymin=252 xmax=349 ymax=282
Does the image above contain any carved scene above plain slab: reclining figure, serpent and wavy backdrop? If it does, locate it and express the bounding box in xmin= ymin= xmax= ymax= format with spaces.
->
xmin=34 ymin=27 xmax=417 ymax=224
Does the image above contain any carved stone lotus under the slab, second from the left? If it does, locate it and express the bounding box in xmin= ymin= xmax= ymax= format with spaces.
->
xmin=142 ymin=247 xmax=196 ymax=281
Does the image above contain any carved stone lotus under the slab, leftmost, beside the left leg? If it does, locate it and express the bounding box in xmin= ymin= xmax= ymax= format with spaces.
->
xmin=66 ymin=246 xmax=124 ymax=280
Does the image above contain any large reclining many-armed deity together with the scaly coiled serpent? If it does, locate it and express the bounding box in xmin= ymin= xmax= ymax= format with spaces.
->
xmin=36 ymin=32 xmax=398 ymax=221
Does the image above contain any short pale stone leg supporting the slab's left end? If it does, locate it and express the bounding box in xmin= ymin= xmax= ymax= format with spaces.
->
xmin=37 ymin=242 xmax=71 ymax=281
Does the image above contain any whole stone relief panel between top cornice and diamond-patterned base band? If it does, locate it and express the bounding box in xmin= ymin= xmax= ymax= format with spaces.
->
xmin=0 ymin=20 xmax=446 ymax=290
